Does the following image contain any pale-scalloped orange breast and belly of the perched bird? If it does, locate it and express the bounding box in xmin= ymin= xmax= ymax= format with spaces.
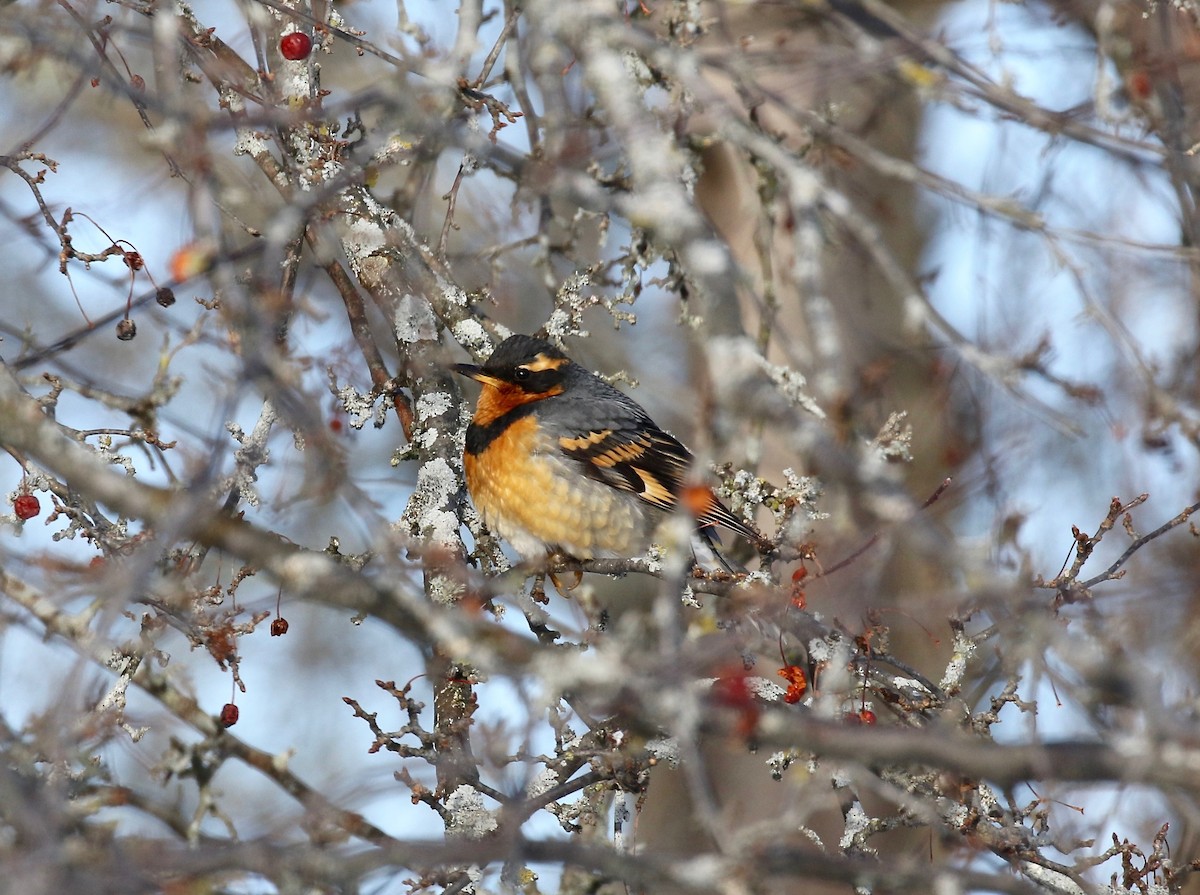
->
xmin=463 ymin=415 xmax=661 ymax=559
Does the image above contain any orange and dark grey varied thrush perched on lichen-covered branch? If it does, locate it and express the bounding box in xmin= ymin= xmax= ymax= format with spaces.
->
xmin=455 ymin=335 xmax=770 ymax=561
